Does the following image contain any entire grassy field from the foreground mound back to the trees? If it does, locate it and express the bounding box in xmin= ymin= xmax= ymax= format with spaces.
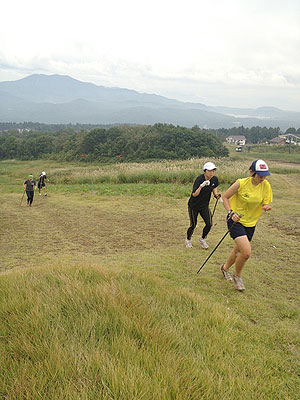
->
xmin=0 ymin=153 xmax=300 ymax=400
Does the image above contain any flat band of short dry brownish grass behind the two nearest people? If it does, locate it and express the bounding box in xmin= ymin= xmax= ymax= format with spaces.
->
xmin=0 ymin=174 xmax=300 ymax=271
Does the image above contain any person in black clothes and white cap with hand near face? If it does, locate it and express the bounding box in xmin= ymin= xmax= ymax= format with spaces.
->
xmin=185 ymin=162 xmax=221 ymax=249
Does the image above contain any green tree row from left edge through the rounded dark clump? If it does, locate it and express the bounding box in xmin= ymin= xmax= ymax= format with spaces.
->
xmin=0 ymin=124 xmax=228 ymax=162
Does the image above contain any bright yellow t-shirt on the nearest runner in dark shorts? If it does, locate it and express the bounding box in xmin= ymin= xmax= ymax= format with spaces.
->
xmin=229 ymin=176 xmax=273 ymax=226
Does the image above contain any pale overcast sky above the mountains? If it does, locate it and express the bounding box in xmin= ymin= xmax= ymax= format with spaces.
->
xmin=0 ymin=0 xmax=300 ymax=112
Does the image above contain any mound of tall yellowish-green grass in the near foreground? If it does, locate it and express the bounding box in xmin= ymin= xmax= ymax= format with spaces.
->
xmin=0 ymin=263 xmax=299 ymax=400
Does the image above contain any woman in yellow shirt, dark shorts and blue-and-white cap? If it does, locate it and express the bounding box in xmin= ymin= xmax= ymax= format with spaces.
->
xmin=220 ymin=160 xmax=272 ymax=291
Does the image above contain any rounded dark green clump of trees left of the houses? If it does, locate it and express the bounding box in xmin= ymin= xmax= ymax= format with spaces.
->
xmin=76 ymin=124 xmax=228 ymax=162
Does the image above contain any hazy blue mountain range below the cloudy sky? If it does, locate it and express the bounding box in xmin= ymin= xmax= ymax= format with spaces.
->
xmin=0 ymin=74 xmax=300 ymax=130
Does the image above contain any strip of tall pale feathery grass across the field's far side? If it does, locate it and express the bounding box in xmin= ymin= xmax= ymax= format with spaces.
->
xmin=0 ymin=154 xmax=300 ymax=191
